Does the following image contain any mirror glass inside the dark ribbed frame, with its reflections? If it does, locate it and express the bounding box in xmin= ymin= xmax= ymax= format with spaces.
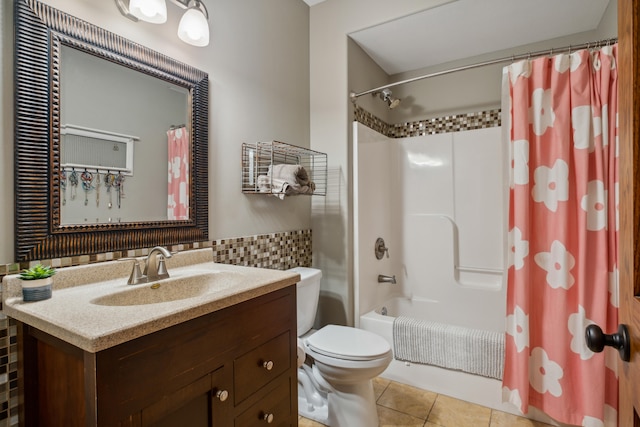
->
xmin=59 ymin=45 xmax=191 ymax=226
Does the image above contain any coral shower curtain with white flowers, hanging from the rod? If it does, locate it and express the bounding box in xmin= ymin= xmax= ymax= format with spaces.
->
xmin=503 ymin=45 xmax=618 ymax=427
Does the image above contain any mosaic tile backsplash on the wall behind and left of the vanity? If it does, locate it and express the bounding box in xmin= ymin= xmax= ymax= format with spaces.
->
xmin=0 ymin=230 xmax=312 ymax=427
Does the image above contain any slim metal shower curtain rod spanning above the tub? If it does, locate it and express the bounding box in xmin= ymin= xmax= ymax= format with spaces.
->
xmin=349 ymin=37 xmax=618 ymax=103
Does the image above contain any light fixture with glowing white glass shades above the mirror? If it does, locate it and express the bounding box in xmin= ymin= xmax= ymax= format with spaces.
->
xmin=114 ymin=0 xmax=209 ymax=47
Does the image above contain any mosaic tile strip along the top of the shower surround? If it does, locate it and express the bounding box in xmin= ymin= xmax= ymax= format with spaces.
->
xmin=354 ymin=105 xmax=502 ymax=138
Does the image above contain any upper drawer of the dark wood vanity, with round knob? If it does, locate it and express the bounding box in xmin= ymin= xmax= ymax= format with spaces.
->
xmin=233 ymin=331 xmax=291 ymax=405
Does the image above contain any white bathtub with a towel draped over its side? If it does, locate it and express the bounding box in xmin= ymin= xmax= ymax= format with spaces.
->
xmin=360 ymin=297 xmax=515 ymax=413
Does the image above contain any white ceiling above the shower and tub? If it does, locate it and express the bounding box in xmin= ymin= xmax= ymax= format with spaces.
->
xmin=350 ymin=0 xmax=609 ymax=75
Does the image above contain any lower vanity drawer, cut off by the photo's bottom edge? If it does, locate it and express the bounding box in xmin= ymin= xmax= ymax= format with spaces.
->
xmin=234 ymin=375 xmax=298 ymax=427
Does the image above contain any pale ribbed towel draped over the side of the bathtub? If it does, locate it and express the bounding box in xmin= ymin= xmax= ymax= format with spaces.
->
xmin=393 ymin=316 xmax=504 ymax=379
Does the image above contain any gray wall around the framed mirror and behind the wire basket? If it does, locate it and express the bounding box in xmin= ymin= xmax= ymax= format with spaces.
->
xmin=0 ymin=0 xmax=310 ymax=264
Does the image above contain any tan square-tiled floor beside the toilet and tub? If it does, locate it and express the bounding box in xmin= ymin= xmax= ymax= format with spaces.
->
xmin=298 ymin=378 xmax=550 ymax=427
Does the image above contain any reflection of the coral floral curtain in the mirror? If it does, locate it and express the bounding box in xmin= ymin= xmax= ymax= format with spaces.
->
xmin=167 ymin=126 xmax=189 ymax=220
